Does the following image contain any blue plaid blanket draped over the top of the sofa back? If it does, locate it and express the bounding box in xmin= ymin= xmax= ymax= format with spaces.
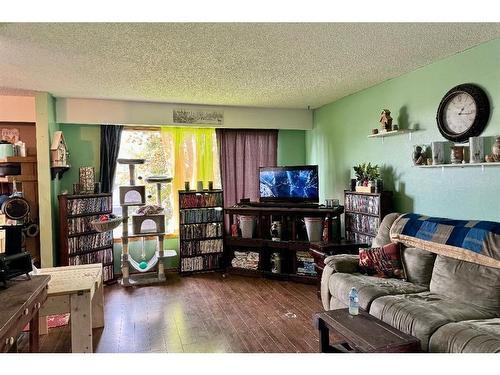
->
xmin=390 ymin=213 xmax=500 ymax=268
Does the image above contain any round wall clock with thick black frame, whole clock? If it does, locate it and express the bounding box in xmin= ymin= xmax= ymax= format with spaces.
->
xmin=436 ymin=83 xmax=490 ymax=142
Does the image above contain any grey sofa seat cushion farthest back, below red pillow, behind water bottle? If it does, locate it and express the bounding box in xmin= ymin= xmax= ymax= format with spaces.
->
xmin=328 ymin=273 xmax=427 ymax=311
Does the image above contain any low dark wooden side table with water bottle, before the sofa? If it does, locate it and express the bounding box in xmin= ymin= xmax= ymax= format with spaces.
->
xmin=314 ymin=309 xmax=421 ymax=353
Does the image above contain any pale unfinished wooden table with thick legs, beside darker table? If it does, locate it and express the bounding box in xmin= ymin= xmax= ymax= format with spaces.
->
xmin=39 ymin=263 xmax=104 ymax=353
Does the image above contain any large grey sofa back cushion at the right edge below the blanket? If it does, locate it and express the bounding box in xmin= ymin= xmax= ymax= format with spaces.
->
xmin=430 ymin=255 xmax=500 ymax=316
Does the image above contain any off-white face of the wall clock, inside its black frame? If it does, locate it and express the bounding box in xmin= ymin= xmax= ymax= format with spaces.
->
xmin=443 ymin=92 xmax=477 ymax=134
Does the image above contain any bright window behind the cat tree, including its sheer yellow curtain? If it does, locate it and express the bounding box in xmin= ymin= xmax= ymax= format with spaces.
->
xmin=113 ymin=127 xmax=221 ymax=238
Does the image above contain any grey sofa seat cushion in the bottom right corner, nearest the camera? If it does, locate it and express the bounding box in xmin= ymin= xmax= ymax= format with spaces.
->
xmin=429 ymin=318 xmax=500 ymax=353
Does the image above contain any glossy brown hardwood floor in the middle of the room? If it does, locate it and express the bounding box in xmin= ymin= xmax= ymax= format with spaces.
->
xmin=28 ymin=274 xmax=322 ymax=353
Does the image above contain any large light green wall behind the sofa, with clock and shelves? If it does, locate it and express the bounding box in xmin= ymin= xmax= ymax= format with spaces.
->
xmin=306 ymin=39 xmax=500 ymax=221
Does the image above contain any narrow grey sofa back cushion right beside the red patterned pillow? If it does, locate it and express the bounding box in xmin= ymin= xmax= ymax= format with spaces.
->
xmin=402 ymin=246 xmax=436 ymax=286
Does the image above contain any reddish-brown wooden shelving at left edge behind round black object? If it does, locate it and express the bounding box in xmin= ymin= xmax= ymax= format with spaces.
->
xmin=0 ymin=156 xmax=40 ymax=265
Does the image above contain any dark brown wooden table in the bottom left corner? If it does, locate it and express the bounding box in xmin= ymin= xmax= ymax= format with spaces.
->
xmin=0 ymin=276 xmax=50 ymax=352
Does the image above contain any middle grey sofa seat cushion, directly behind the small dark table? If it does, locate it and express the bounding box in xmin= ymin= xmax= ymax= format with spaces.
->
xmin=370 ymin=292 xmax=495 ymax=351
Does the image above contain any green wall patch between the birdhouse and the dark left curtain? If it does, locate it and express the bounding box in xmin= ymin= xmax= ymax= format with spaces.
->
xmin=60 ymin=124 xmax=101 ymax=194
